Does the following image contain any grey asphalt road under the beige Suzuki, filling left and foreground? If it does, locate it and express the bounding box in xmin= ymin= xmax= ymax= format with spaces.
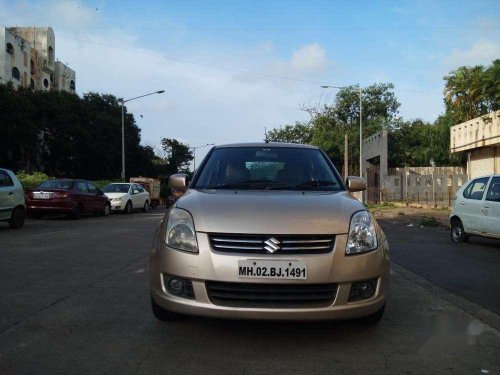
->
xmin=0 ymin=210 xmax=500 ymax=375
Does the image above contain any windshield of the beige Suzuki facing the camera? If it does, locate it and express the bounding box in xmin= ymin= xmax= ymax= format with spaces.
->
xmin=193 ymin=146 xmax=343 ymax=191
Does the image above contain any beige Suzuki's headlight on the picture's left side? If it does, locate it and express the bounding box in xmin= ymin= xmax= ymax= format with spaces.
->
xmin=165 ymin=208 xmax=198 ymax=253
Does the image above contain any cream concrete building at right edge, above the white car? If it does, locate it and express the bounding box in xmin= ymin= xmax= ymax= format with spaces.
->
xmin=450 ymin=111 xmax=500 ymax=179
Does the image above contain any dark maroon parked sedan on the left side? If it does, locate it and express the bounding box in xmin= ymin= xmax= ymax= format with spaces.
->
xmin=25 ymin=179 xmax=111 ymax=219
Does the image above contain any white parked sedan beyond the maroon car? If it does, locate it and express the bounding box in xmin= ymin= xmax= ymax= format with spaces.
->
xmin=103 ymin=183 xmax=150 ymax=214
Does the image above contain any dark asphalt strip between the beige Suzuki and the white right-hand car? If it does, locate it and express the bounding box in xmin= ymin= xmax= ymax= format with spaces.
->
xmin=380 ymin=221 xmax=500 ymax=314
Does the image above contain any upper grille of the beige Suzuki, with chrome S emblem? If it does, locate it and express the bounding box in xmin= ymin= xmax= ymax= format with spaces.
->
xmin=209 ymin=233 xmax=335 ymax=255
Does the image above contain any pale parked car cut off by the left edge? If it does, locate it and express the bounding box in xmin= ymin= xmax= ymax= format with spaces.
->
xmin=0 ymin=168 xmax=26 ymax=229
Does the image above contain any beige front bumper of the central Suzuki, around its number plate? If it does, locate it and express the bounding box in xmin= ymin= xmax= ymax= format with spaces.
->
xmin=150 ymin=232 xmax=390 ymax=320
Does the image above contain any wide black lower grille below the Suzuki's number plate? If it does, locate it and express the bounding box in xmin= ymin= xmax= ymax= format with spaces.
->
xmin=205 ymin=281 xmax=337 ymax=308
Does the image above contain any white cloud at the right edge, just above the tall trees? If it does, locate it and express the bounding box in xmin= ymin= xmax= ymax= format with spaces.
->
xmin=444 ymin=40 xmax=500 ymax=68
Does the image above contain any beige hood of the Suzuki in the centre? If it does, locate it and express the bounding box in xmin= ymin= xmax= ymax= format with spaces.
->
xmin=176 ymin=190 xmax=365 ymax=234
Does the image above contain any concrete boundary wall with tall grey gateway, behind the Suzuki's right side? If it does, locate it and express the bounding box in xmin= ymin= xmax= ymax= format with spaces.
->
xmin=362 ymin=130 xmax=468 ymax=205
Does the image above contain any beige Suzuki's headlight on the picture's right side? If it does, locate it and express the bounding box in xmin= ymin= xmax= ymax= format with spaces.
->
xmin=345 ymin=211 xmax=377 ymax=255
